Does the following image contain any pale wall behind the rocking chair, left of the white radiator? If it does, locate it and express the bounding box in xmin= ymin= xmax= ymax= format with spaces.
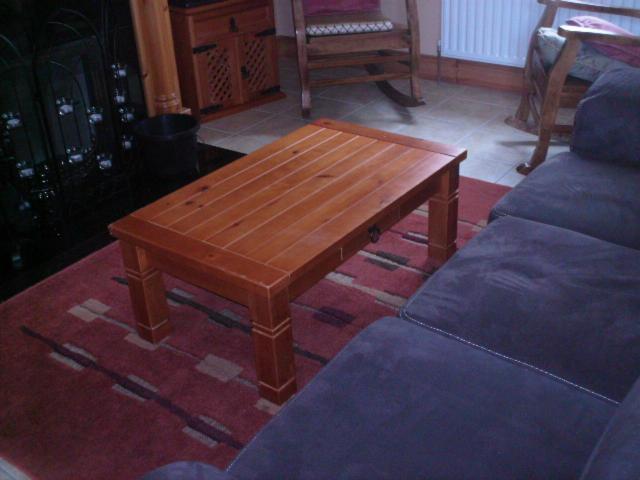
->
xmin=273 ymin=0 xmax=442 ymax=55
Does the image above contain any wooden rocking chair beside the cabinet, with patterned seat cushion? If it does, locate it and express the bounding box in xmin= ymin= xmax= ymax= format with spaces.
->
xmin=292 ymin=0 xmax=424 ymax=117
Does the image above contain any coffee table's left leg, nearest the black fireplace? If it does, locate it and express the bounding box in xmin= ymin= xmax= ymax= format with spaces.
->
xmin=120 ymin=240 xmax=171 ymax=343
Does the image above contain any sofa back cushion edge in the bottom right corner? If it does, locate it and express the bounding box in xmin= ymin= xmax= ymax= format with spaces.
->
xmin=580 ymin=380 xmax=640 ymax=480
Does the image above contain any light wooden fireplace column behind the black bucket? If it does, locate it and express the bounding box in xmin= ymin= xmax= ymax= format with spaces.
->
xmin=130 ymin=0 xmax=183 ymax=117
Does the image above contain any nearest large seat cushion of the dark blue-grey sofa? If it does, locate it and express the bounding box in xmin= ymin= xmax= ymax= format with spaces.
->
xmin=228 ymin=318 xmax=616 ymax=480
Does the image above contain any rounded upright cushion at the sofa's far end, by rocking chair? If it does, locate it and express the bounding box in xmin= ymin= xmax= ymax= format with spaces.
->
xmin=571 ymin=66 xmax=640 ymax=167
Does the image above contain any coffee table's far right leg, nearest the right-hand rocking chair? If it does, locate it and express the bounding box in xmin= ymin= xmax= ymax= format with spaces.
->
xmin=429 ymin=165 xmax=459 ymax=266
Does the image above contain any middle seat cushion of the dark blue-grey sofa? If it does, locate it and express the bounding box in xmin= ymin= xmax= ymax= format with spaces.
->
xmin=401 ymin=217 xmax=640 ymax=401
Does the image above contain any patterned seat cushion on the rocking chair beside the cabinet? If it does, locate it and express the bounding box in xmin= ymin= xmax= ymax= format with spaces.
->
xmin=306 ymin=12 xmax=393 ymax=37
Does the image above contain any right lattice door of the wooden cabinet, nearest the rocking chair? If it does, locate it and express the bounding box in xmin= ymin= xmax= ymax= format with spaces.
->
xmin=241 ymin=30 xmax=280 ymax=100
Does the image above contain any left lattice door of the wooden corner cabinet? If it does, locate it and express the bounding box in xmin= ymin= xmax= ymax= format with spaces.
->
xmin=193 ymin=37 xmax=242 ymax=115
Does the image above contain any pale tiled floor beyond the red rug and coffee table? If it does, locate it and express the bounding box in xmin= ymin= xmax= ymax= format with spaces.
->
xmin=200 ymin=58 xmax=568 ymax=186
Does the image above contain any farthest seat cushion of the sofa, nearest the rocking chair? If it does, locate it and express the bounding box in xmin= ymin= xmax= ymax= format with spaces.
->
xmin=490 ymin=152 xmax=640 ymax=249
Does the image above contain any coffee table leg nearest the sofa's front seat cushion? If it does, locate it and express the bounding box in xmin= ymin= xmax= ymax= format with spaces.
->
xmin=249 ymin=291 xmax=297 ymax=405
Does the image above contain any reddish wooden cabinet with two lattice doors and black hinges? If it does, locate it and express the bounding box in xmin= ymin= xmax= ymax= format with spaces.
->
xmin=171 ymin=0 xmax=284 ymax=121
